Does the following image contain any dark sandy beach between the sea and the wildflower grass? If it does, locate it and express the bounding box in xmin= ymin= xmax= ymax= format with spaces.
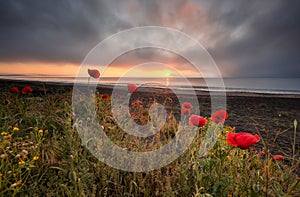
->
xmin=0 ymin=79 xmax=300 ymax=154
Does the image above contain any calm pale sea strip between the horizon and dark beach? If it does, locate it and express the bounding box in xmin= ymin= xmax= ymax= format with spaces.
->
xmin=0 ymin=75 xmax=300 ymax=94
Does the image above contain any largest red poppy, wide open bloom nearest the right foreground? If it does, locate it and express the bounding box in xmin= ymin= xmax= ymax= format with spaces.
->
xmin=226 ymin=132 xmax=260 ymax=149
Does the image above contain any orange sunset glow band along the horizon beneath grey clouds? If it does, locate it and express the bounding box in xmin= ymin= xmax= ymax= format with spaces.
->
xmin=0 ymin=62 xmax=202 ymax=78
